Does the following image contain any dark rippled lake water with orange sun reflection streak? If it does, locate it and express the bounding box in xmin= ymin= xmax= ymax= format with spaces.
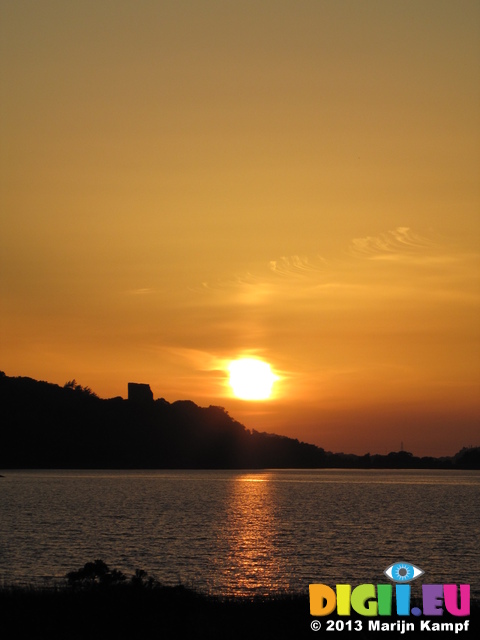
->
xmin=0 ymin=470 xmax=480 ymax=597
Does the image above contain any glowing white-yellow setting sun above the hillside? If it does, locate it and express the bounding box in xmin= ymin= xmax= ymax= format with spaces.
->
xmin=228 ymin=358 xmax=279 ymax=400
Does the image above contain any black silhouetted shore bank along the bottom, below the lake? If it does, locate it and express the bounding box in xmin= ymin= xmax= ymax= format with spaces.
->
xmin=0 ymin=584 xmax=480 ymax=640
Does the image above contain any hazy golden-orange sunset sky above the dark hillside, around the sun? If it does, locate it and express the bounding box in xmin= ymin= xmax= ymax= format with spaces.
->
xmin=0 ymin=0 xmax=480 ymax=456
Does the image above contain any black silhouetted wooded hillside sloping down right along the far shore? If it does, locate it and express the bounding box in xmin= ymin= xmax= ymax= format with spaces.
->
xmin=0 ymin=372 xmax=480 ymax=469
